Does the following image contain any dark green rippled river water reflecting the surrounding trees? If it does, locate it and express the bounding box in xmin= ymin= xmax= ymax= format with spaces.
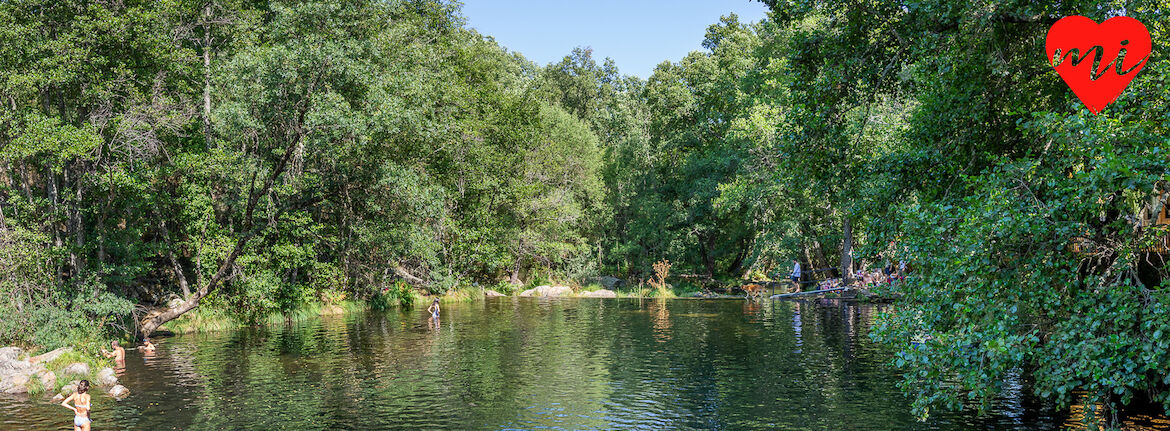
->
xmin=0 ymin=297 xmax=1155 ymax=430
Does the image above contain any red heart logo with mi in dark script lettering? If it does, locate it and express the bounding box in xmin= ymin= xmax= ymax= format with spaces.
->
xmin=1045 ymin=15 xmax=1152 ymax=114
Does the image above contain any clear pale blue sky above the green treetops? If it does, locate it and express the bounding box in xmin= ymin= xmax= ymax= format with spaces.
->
xmin=463 ymin=0 xmax=768 ymax=78
